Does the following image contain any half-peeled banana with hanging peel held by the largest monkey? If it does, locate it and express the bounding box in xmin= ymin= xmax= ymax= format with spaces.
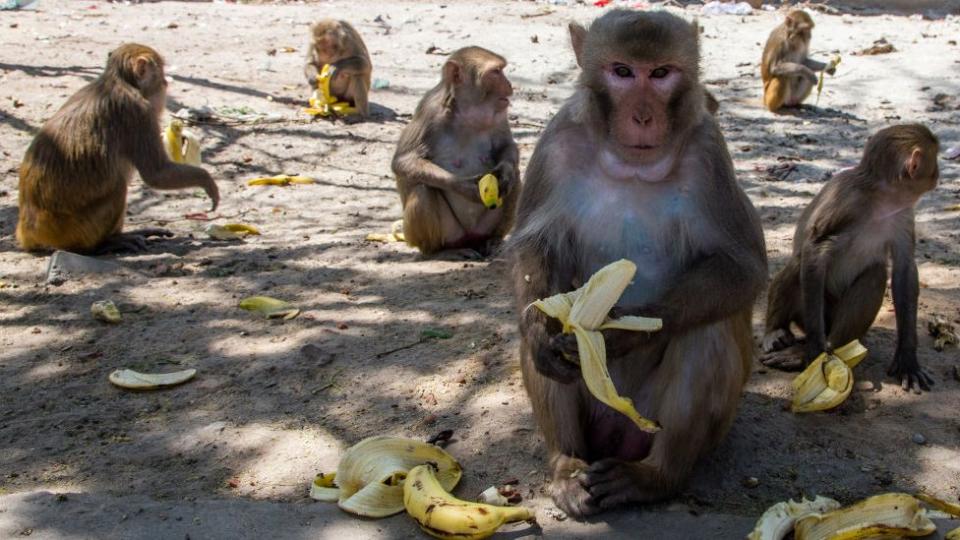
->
xmin=528 ymin=259 xmax=663 ymax=433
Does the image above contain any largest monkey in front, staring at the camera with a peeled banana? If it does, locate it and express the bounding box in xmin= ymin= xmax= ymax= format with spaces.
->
xmin=511 ymin=9 xmax=767 ymax=517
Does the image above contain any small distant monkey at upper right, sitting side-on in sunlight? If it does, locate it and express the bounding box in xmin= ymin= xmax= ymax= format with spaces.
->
xmin=760 ymin=9 xmax=836 ymax=112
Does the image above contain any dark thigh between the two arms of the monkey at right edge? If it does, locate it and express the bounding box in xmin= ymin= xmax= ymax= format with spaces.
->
xmin=826 ymin=264 xmax=887 ymax=347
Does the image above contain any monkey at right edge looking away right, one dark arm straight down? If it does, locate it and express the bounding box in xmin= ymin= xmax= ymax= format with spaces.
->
xmin=761 ymin=124 xmax=939 ymax=390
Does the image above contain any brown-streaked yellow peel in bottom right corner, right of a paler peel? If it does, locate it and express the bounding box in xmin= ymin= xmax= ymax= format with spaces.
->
xmin=794 ymin=493 xmax=937 ymax=540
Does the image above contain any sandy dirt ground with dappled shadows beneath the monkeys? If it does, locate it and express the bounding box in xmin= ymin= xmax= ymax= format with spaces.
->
xmin=0 ymin=0 xmax=960 ymax=538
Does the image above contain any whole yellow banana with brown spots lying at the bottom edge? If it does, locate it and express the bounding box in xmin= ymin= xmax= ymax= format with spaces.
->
xmin=403 ymin=463 xmax=533 ymax=540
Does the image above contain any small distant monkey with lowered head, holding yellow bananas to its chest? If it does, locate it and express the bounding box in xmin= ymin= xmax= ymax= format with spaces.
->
xmin=303 ymin=19 xmax=373 ymax=116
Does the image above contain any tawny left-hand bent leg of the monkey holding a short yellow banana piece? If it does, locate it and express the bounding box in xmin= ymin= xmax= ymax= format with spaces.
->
xmin=403 ymin=184 xmax=466 ymax=255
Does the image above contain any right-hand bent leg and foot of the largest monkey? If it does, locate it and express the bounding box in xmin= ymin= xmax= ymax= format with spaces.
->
xmin=578 ymin=311 xmax=753 ymax=509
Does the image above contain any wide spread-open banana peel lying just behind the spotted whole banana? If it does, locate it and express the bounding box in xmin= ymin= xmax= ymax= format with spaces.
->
xmin=310 ymin=436 xmax=462 ymax=517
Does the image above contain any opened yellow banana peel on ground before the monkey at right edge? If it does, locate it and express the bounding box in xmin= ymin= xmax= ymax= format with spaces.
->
xmin=790 ymin=340 xmax=867 ymax=413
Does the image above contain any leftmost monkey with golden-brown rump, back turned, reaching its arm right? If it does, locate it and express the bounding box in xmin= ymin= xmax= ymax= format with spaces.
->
xmin=17 ymin=43 xmax=220 ymax=252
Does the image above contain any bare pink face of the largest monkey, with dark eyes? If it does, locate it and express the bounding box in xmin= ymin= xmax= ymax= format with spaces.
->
xmin=603 ymin=62 xmax=683 ymax=165
